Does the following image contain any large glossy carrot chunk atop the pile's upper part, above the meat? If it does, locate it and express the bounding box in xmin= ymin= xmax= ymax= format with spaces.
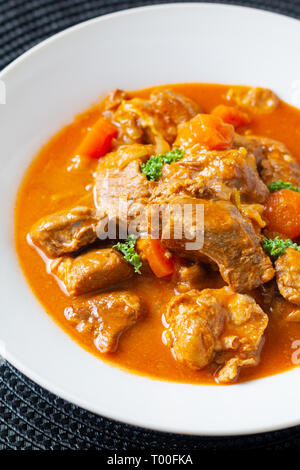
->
xmin=174 ymin=114 xmax=234 ymax=150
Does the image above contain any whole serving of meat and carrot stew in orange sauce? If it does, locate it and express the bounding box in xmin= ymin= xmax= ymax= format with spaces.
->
xmin=15 ymin=84 xmax=300 ymax=384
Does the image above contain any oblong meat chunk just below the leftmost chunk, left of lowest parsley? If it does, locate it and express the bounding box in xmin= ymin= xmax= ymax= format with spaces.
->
xmin=50 ymin=248 xmax=134 ymax=295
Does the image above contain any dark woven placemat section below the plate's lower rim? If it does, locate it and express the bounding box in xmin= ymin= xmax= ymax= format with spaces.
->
xmin=0 ymin=364 xmax=300 ymax=452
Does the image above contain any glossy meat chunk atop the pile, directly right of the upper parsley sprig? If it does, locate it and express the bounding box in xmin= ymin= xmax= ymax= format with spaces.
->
xmin=161 ymin=148 xmax=269 ymax=203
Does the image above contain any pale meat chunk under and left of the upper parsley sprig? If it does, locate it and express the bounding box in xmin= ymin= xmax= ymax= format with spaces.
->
xmin=95 ymin=144 xmax=154 ymax=232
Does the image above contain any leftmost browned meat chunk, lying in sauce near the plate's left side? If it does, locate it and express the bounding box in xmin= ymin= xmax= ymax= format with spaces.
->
xmin=29 ymin=207 xmax=97 ymax=258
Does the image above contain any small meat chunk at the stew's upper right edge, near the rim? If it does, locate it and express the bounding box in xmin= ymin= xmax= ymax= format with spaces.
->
xmin=226 ymin=87 xmax=279 ymax=114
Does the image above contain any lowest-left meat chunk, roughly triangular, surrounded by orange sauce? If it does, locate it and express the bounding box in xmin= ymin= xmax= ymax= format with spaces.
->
xmin=65 ymin=291 xmax=143 ymax=353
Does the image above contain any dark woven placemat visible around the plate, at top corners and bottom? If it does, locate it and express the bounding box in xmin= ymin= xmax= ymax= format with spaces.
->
xmin=0 ymin=0 xmax=300 ymax=453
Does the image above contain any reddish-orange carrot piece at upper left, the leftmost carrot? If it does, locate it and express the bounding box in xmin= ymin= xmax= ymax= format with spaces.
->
xmin=76 ymin=118 xmax=118 ymax=158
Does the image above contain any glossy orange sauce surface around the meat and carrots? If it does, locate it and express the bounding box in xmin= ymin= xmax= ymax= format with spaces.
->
xmin=15 ymin=84 xmax=300 ymax=384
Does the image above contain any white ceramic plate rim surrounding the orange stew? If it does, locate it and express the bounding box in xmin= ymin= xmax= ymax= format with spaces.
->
xmin=0 ymin=4 xmax=300 ymax=435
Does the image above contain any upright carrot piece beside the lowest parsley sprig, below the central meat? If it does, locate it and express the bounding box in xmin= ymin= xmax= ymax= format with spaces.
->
xmin=137 ymin=238 xmax=174 ymax=277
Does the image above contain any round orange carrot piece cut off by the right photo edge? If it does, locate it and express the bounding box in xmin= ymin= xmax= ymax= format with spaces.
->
xmin=264 ymin=189 xmax=300 ymax=240
